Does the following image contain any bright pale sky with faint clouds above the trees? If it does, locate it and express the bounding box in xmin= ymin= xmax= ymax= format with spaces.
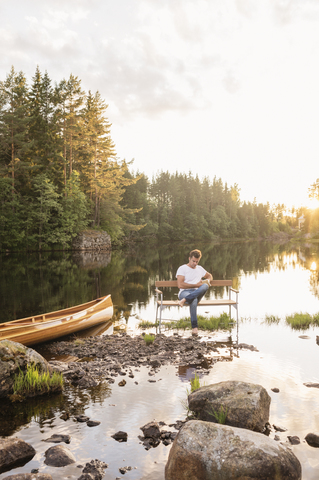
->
xmin=0 ymin=0 xmax=319 ymax=207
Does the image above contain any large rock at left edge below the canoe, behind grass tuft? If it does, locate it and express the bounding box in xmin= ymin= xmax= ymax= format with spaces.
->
xmin=0 ymin=340 xmax=52 ymax=398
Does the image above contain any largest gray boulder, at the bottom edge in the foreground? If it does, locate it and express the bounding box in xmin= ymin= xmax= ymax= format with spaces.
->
xmin=165 ymin=420 xmax=301 ymax=480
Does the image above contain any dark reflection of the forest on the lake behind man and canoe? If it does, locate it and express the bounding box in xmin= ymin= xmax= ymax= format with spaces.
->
xmin=0 ymin=242 xmax=319 ymax=323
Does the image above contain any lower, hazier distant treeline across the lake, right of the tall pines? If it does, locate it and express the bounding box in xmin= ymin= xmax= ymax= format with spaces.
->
xmin=122 ymin=172 xmax=298 ymax=242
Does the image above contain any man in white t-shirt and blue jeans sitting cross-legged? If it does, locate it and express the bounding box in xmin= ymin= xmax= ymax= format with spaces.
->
xmin=176 ymin=249 xmax=213 ymax=337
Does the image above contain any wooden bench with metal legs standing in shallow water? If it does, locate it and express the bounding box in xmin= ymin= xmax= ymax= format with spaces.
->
xmin=155 ymin=280 xmax=239 ymax=328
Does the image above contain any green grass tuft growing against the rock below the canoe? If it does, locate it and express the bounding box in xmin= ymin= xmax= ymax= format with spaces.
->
xmin=13 ymin=365 xmax=63 ymax=397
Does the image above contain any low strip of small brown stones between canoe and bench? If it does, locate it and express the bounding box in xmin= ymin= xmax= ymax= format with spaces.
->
xmin=49 ymin=333 xmax=230 ymax=388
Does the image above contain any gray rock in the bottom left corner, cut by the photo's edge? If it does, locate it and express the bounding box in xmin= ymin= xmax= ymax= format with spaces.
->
xmin=0 ymin=437 xmax=36 ymax=473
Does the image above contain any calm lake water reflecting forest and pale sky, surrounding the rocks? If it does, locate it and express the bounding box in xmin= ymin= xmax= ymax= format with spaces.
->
xmin=0 ymin=242 xmax=319 ymax=480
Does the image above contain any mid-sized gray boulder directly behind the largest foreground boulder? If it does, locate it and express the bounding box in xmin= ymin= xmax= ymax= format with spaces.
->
xmin=188 ymin=381 xmax=271 ymax=432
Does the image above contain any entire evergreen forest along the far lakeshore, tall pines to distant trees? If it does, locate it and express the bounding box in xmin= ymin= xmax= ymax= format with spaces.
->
xmin=0 ymin=67 xmax=319 ymax=251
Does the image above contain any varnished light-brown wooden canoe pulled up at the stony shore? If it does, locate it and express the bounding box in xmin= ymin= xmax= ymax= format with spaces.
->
xmin=0 ymin=295 xmax=113 ymax=346
